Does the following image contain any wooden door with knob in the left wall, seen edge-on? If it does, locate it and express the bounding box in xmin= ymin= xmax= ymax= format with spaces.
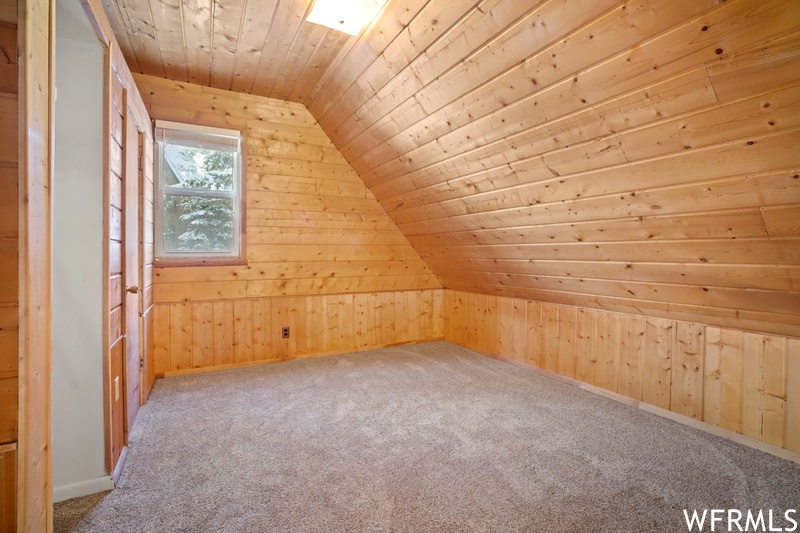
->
xmin=122 ymin=102 xmax=141 ymax=434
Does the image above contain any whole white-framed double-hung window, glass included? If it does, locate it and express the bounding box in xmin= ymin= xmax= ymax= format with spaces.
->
xmin=155 ymin=121 xmax=242 ymax=262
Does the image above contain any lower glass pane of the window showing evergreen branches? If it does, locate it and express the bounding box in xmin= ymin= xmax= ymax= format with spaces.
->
xmin=164 ymin=194 xmax=233 ymax=252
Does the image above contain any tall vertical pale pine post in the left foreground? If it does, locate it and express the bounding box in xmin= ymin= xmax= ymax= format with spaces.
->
xmin=16 ymin=0 xmax=55 ymax=532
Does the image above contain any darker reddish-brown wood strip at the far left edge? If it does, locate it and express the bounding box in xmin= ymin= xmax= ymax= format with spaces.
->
xmin=0 ymin=13 xmax=19 ymax=531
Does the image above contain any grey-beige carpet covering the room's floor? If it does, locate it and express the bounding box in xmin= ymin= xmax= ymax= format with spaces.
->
xmin=55 ymin=342 xmax=800 ymax=533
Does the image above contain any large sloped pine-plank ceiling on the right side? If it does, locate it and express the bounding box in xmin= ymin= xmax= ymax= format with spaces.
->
xmin=308 ymin=0 xmax=800 ymax=336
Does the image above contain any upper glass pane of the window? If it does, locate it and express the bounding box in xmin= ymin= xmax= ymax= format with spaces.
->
xmin=164 ymin=144 xmax=234 ymax=191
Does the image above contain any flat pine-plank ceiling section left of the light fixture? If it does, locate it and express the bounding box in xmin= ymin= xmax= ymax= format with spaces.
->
xmin=97 ymin=0 xmax=350 ymax=102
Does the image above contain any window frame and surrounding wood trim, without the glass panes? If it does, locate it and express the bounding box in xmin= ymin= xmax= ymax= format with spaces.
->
xmin=153 ymin=120 xmax=247 ymax=267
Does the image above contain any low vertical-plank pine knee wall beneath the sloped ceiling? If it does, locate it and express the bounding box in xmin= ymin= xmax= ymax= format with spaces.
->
xmin=445 ymin=290 xmax=800 ymax=452
